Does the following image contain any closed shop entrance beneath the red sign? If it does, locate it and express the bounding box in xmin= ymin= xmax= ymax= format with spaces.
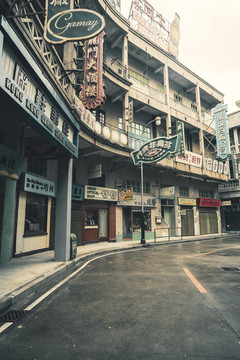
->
xmin=199 ymin=208 xmax=218 ymax=235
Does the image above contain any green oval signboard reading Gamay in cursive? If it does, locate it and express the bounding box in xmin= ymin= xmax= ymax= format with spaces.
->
xmin=44 ymin=0 xmax=105 ymax=44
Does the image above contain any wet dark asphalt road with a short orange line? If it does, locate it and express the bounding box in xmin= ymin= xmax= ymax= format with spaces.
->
xmin=0 ymin=239 xmax=240 ymax=360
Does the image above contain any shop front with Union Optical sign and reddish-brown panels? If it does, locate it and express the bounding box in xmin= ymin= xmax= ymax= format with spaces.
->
xmin=81 ymin=185 xmax=118 ymax=245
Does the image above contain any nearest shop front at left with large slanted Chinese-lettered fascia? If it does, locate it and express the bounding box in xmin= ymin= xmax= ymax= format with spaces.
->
xmin=0 ymin=17 xmax=79 ymax=262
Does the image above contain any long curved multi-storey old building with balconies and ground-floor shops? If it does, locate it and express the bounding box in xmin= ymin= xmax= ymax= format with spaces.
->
xmin=0 ymin=0 xmax=229 ymax=262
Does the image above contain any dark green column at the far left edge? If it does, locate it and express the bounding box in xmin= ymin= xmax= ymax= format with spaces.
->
xmin=0 ymin=178 xmax=17 ymax=263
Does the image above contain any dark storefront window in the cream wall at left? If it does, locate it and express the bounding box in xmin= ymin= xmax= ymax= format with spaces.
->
xmin=24 ymin=193 xmax=47 ymax=236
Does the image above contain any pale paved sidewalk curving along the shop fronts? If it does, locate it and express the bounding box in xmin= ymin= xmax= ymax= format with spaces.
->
xmin=0 ymin=234 xmax=239 ymax=313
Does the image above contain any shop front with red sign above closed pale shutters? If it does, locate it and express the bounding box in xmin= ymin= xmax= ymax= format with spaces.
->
xmin=197 ymin=198 xmax=221 ymax=235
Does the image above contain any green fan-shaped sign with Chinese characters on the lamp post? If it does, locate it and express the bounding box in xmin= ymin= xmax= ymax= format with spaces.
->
xmin=131 ymin=135 xmax=180 ymax=165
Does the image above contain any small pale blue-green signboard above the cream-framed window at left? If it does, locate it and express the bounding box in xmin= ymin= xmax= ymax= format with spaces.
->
xmin=22 ymin=173 xmax=56 ymax=197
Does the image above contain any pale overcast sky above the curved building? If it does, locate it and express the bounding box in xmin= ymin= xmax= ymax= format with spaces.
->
xmin=121 ymin=0 xmax=240 ymax=113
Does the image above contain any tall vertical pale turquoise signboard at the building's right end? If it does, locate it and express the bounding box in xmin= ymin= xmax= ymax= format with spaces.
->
xmin=212 ymin=104 xmax=230 ymax=159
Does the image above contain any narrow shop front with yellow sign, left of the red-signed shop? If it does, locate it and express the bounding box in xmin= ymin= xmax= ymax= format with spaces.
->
xmin=178 ymin=198 xmax=197 ymax=236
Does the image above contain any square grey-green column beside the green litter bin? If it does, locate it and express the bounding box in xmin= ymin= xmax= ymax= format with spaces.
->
xmin=54 ymin=159 xmax=73 ymax=261
